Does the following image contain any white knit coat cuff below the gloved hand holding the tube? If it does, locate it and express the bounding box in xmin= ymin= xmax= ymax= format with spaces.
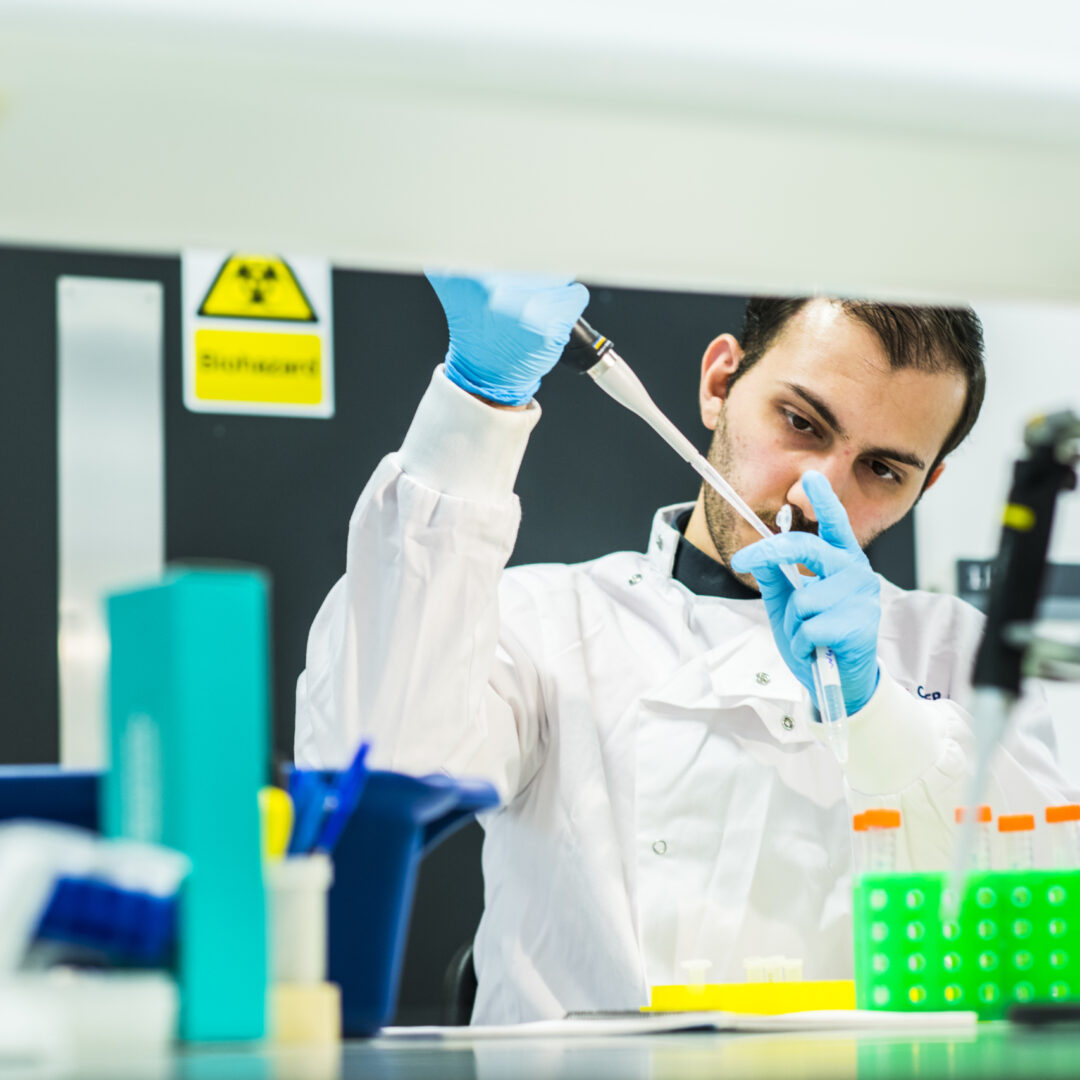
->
xmin=845 ymin=663 xmax=945 ymax=795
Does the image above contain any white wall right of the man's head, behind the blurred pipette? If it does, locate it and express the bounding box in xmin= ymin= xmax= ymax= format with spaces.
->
xmin=916 ymin=303 xmax=1080 ymax=785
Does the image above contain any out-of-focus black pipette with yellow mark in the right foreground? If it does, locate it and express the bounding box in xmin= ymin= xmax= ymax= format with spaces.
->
xmin=943 ymin=413 xmax=1080 ymax=917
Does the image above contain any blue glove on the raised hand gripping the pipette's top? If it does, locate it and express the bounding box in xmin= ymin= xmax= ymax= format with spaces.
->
xmin=426 ymin=270 xmax=589 ymax=405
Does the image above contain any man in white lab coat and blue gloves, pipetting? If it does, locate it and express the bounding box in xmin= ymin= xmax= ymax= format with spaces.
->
xmin=296 ymin=275 xmax=1066 ymax=1023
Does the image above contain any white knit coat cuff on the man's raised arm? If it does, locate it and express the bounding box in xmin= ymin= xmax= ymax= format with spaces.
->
xmin=401 ymin=364 xmax=540 ymax=502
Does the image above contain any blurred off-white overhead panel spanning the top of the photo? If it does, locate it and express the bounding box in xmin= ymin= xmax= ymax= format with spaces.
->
xmin=0 ymin=0 xmax=1080 ymax=302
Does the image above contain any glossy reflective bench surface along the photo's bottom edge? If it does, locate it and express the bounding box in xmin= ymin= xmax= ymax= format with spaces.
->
xmin=44 ymin=1023 xmax=1080 ymax=1080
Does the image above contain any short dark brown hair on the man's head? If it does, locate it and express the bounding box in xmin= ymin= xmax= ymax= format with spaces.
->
xmin=728 ymin=296 xmax=986 ymax=478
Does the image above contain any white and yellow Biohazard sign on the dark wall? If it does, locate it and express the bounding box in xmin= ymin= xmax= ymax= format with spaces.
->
xmin=183 ymin=251 xmax=334 ymax=417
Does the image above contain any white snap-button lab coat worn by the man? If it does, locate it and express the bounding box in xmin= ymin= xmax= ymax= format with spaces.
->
xmin=296 ymin=370 xmax=1066 ymax=1023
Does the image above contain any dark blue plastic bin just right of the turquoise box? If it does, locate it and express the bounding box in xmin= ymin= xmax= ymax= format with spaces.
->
xmin=328 ymin=771 xmax=499 ymax=1037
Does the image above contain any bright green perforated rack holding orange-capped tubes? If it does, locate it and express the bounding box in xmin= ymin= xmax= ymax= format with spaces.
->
xmin=852 ymin=870 xmax=1080 ymax=1020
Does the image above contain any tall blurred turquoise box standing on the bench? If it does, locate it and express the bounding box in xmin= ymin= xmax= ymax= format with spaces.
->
xmin=102 ymin=569 xmax=270 ymax=1041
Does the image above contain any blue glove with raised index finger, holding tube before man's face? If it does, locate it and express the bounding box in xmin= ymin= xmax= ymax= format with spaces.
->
xmin=731 ymin=472 xmax=881 ymax=713
